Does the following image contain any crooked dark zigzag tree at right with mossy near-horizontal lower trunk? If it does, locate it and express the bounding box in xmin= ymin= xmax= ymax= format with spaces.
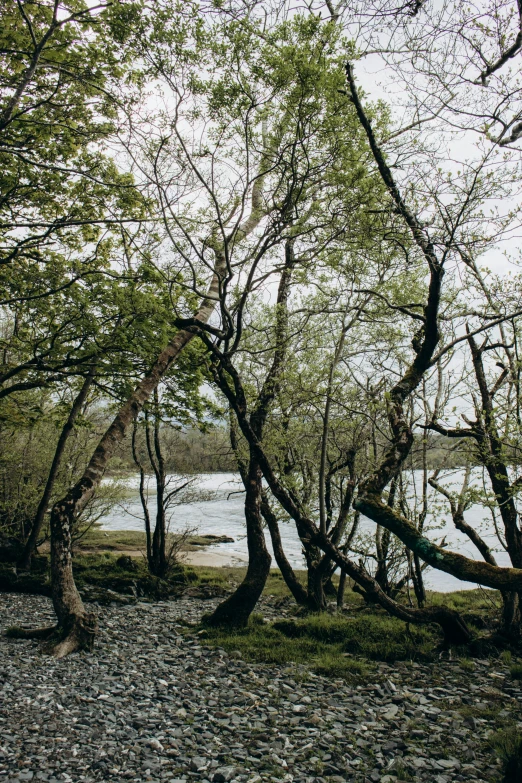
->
xmin=322 ymin=4 xmax=520 ymax=608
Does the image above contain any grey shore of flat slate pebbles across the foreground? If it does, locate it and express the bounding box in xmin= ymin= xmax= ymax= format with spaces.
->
xmin=0 ymin=594 xmax=522 ymax=783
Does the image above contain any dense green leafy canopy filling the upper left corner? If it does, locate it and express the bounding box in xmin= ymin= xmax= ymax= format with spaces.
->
xmin=0 ymin=0 xmax=146 ymax=410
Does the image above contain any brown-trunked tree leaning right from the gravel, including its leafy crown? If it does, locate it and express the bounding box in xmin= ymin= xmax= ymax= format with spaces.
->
xmin=15 ymin=3 xmax=288 ymax=656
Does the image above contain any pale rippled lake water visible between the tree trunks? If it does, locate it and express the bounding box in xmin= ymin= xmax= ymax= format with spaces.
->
xmin=101 ymin=471 xmax=509 ymax=592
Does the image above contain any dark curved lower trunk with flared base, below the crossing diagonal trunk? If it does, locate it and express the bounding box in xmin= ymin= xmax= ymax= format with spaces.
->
xmin=205 ymin=457 xmax=272 ymax=628
